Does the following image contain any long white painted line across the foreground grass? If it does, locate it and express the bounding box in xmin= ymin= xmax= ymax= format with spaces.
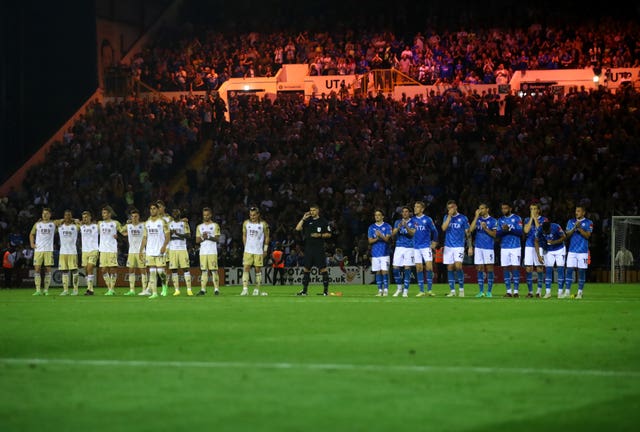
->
xmin=0 ymin=358 xmax=640 ymax=378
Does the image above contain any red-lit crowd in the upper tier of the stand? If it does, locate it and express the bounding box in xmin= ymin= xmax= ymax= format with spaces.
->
xmin=131 ymin=12 xmax=640 ymax=91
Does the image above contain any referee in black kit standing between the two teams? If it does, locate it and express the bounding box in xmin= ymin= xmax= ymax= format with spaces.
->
xmin=296 ymin=204 xmax=331 ymax=296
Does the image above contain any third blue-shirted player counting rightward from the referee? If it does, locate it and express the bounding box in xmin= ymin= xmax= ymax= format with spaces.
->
xmin=407 ymin=201 xmax=438 ymax=297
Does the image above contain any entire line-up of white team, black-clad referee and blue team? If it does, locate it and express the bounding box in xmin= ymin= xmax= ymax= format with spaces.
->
xmin=29 ymin=200 xmax=593 ymax=299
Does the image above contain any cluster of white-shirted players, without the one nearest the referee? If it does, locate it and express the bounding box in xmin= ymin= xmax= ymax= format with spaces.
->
xmin=29 ymin=201 xmax=235 ymax=299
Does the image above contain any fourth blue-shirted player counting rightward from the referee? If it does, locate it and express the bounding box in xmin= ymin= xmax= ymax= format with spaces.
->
xmin=442 ymin=200 xmax=473 ymax=297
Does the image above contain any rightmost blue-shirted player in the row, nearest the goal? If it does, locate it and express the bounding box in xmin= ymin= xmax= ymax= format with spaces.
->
xmin=564 ymin=206 xmax=593 ymax=299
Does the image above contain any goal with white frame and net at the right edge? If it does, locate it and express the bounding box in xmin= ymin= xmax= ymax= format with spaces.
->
xmin=611 ymin=216 xmax=640 ymax=283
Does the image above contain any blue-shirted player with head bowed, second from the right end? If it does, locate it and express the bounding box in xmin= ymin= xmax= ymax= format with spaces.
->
xmin=534 ymin=221 xmax=567 ymax=299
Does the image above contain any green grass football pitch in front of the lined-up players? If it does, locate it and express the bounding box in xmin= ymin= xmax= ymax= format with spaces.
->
xmin=0 ymin=284 xmax=640 ymax=432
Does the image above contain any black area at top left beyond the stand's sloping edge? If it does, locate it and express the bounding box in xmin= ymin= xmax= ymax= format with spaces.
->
xmin=0 ymin=0 xmax=98 ymax=182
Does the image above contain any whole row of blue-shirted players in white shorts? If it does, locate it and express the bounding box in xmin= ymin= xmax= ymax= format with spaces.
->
xmin=368 ymin=200 xmax=593 ymax=299
